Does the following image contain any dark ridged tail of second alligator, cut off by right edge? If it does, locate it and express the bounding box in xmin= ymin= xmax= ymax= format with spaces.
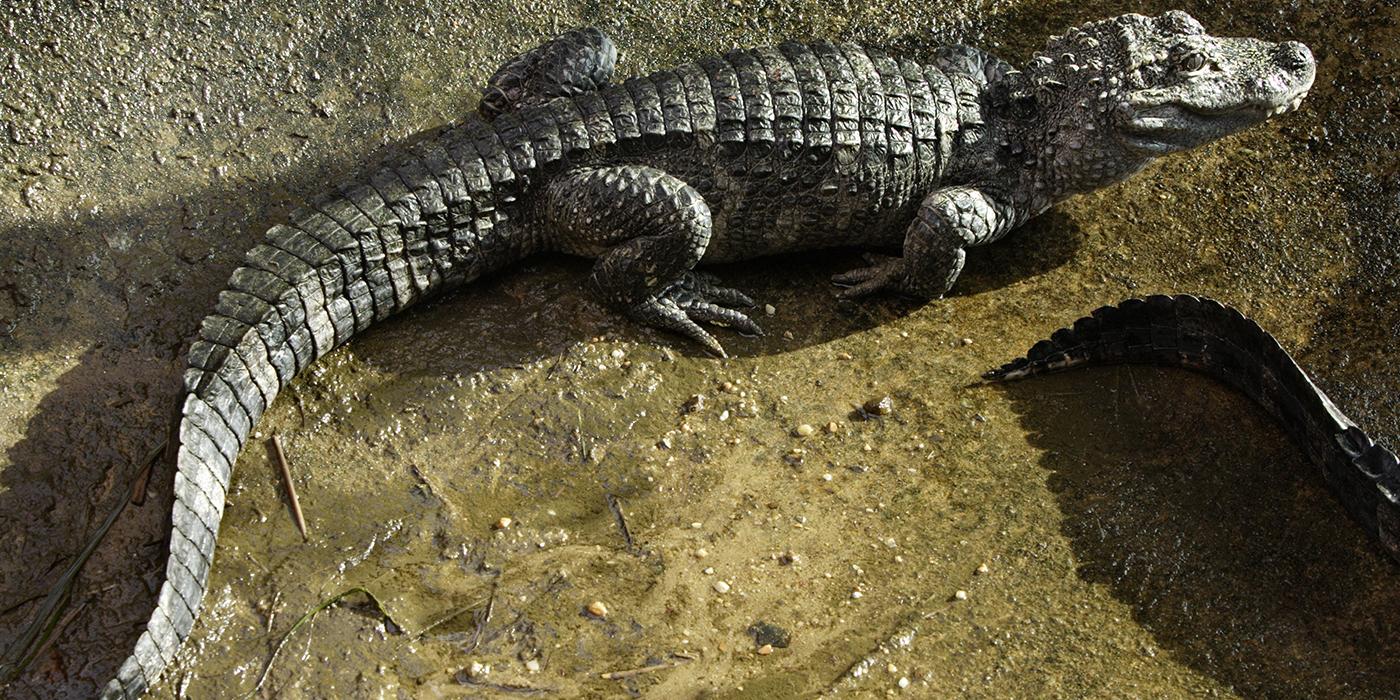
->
xmin=983 ymin=294 xmax=1400 ymax=561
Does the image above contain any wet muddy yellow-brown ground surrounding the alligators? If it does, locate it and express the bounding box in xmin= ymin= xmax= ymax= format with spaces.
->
xmin=0 ymin=0 xmax=1400 ymax=697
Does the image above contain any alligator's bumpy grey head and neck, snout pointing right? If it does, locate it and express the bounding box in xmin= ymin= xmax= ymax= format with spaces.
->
xmin=1023 ymin=11 xmax=1316 ymax=199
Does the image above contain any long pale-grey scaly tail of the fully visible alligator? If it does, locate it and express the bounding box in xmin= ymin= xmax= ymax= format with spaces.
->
xmin=102 ymin=135 xmax=514 ymax=699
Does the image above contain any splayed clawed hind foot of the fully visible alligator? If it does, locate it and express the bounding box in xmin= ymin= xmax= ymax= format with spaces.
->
xmin=629 ymin=272 xmax=763 ymax=357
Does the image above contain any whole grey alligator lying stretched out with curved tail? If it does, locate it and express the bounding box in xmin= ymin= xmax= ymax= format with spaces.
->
xmin=95 ymin=11 xmax=1316 ymax=697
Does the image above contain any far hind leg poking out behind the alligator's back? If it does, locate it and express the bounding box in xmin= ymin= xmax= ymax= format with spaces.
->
xmin=477 ymin=27 xmax=617 ymax=120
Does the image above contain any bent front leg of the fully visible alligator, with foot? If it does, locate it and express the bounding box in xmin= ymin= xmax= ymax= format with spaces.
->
xmin=832 ymin=188 xmax=1023 ymax=300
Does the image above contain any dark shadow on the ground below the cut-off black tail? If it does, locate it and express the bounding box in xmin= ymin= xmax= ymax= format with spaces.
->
xmin=1004 ymin=367 xmax=1400 ymax=697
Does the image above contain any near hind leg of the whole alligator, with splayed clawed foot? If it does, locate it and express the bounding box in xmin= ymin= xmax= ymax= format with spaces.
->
xmin=540 ymin=167 xmax=763 ymax=357
